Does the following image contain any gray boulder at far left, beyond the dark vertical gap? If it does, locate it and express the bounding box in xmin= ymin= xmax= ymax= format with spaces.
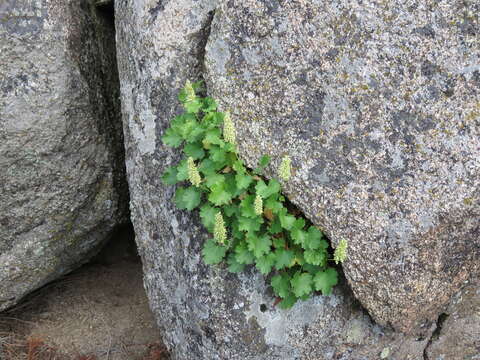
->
xmin=0 ymin=0 xmax=128 ymax=310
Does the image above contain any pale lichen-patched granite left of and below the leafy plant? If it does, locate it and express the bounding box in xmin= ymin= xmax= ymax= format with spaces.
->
xmin=115 ymin=0 xmax=452 ymax=360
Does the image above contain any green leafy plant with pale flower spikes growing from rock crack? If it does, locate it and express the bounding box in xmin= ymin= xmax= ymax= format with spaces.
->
xmin=162 ymin=81 xmax=347 ymax=308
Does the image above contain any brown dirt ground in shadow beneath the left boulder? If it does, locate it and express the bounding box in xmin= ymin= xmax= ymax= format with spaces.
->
xmin=0 ymin=228 xmax=168 ymax=360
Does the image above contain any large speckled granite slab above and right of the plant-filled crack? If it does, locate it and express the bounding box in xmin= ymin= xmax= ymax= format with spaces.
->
xmin=205 ymin=0 xmax=480 ymax=333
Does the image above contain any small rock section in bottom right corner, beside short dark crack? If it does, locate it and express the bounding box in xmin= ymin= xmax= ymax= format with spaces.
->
xmin=425 ymin=280 xmax=480 ymax=360
